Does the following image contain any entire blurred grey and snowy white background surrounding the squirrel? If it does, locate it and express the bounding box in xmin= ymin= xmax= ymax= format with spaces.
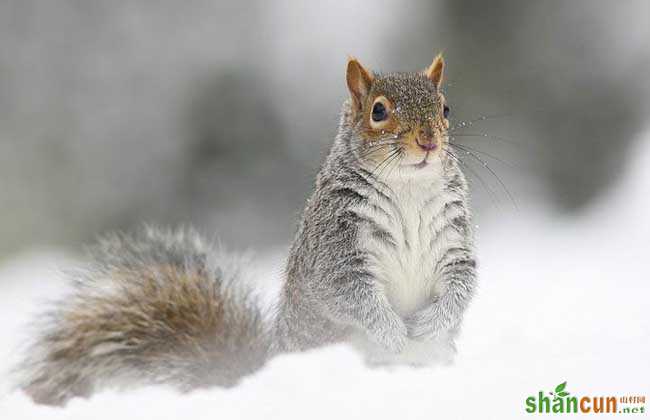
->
xmin=0 ymin=0 xmax=650 ymax=419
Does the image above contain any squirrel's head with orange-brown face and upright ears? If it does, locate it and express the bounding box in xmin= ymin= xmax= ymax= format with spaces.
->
xmin=344 ymin=54 xmax=449 ymax=176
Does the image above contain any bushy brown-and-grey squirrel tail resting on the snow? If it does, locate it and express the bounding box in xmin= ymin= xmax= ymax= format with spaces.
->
xmin=20 ymin=228 xmax=269 ymax=405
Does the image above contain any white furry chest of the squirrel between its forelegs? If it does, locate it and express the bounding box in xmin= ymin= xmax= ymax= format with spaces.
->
xmin=359 ymin=173 xmax=464 ymax=316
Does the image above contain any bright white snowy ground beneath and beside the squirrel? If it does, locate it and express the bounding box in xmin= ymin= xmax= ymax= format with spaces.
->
xmin=0 ymin=136 xmax=650 ymax=420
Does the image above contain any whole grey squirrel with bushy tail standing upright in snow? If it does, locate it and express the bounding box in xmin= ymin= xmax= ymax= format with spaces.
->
xmin=18 ymin=55 xmax=476 ymax=405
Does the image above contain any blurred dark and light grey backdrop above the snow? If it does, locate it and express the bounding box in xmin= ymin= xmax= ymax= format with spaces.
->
xmin=0 ymin=0 xmax=650 ymax=256
